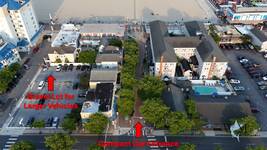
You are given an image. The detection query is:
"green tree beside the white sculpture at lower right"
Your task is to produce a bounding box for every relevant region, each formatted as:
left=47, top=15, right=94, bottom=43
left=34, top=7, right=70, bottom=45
left=231, top=116, right=260, bottom=135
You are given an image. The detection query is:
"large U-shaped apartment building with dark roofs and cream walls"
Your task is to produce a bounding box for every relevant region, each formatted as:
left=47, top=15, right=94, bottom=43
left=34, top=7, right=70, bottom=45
left=150, top=21, right=228, bottom=79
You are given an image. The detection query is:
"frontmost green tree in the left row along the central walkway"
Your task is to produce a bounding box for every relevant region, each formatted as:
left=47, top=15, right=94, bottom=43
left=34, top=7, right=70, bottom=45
left=118, top=99, right=134, bottom=117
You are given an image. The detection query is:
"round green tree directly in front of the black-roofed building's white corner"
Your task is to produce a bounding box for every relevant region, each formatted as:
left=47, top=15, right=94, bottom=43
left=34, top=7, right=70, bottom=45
left=84, top=113, right=109, bottom=134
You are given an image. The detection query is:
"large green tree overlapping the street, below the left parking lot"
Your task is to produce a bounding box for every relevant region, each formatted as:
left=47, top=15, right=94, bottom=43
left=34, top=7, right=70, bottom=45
left=45, top=133, right=76, bottom=150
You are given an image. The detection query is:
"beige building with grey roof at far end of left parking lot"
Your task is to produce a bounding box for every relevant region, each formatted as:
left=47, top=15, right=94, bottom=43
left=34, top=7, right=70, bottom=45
left=48, top=46, right=78, bottom=63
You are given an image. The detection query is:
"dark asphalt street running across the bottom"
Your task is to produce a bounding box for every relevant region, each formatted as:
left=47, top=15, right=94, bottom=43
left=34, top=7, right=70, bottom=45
left=0, top=135, right=267, bottom=150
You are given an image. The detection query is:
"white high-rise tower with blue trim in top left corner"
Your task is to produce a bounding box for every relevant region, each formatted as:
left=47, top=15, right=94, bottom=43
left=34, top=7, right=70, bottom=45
left=0, top=0, right=40, bottom=46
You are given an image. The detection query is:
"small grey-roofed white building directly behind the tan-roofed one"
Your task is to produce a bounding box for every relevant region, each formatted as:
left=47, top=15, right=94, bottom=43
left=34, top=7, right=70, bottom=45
left=95, top=53, right=122, bottom=68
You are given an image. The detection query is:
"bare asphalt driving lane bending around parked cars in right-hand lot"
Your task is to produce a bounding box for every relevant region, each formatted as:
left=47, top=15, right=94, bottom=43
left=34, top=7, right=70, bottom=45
left=224, top=50, right=267, bottom=131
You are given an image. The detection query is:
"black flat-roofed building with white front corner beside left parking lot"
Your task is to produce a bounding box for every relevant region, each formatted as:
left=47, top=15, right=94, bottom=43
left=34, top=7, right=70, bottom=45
left=80, top=83, right=116, bottom=120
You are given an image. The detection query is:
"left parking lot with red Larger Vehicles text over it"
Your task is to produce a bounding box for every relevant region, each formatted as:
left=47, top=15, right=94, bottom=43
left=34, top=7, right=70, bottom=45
left=9, top=66, right=90, bottom=127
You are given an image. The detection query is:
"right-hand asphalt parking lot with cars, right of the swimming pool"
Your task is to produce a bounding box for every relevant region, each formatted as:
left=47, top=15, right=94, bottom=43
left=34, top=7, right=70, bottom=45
left=224, top=50, right=267, bottom=131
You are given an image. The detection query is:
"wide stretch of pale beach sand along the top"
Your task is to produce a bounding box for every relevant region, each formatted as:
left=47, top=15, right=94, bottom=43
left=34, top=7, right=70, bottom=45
left=33, top=0, right=216, bottom=23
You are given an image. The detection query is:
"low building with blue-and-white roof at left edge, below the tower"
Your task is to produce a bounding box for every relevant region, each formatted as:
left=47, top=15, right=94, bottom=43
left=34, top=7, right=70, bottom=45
left=0, top=38, right=21, bottom=70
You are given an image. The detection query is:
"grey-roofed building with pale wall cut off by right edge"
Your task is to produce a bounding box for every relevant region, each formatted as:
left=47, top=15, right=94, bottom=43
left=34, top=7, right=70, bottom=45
left=249, top=28, right=267, bottom=51
